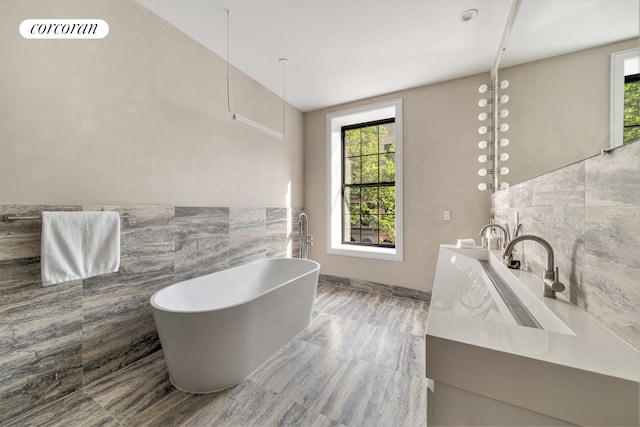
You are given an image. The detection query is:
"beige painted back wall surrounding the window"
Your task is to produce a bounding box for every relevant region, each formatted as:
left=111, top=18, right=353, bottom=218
left=304, top=74, right=490, bottom=291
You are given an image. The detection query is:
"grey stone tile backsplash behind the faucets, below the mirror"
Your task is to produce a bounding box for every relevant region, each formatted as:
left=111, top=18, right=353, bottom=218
left=492, top=143, right=640, bottom=349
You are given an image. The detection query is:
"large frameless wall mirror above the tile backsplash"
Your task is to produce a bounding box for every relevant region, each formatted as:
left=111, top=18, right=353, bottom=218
left=498, top=0, right=640, bottom=185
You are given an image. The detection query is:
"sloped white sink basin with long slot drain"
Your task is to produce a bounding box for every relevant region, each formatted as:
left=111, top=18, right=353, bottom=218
left=431, top=247, right=574, bottom=335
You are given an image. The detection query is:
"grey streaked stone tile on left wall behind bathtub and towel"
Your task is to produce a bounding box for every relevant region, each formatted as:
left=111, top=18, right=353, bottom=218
left=0, top=205, right=300, bottom=425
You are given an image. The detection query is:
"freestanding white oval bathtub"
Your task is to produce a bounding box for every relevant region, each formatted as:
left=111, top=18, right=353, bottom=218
left=151, top=258, right=320, bottom=393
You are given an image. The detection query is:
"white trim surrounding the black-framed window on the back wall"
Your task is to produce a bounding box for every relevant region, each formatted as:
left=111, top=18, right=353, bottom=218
left=327, top=98, right=403, bottom=261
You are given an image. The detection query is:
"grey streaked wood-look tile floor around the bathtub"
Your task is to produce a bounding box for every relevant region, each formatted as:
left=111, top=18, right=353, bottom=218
left=6, top=285, right=428, bottom=427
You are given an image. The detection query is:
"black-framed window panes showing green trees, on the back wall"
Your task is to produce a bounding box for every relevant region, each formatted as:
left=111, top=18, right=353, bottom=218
left=342, top=119, right=396, bottom=248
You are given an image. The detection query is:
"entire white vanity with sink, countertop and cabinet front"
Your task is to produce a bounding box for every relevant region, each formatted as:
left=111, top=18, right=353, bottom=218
left=425, top=245, right=640, bottom=426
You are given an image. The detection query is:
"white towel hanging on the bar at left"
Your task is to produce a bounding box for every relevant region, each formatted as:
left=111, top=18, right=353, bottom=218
left=40, top=212, right=120, bottom=286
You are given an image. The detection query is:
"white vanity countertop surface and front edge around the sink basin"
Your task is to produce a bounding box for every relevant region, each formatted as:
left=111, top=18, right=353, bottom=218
left=427, top=245, right=640, bottom=383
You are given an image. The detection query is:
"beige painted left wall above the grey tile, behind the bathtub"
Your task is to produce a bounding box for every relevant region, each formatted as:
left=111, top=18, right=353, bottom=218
left=0, top=0, right=303, bottom=207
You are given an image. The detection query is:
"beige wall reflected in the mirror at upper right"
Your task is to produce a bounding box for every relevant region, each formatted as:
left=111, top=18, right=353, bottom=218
left=499, top=39, right=639, bottom=185
